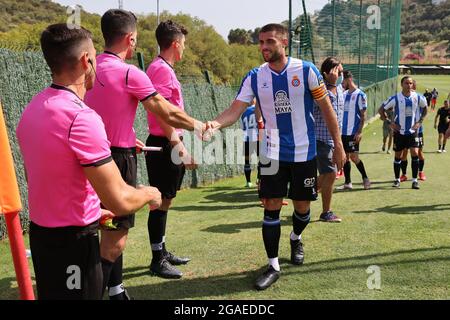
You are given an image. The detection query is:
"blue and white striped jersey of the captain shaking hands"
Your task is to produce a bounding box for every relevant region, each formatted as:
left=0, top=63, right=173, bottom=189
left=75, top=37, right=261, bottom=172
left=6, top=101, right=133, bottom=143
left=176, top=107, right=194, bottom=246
left=236, top=58, right=328, bottom=162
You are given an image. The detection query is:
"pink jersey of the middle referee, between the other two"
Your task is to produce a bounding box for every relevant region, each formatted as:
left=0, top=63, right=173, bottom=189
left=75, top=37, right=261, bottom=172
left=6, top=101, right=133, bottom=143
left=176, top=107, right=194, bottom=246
left=84, top=52, right=157, bottom=148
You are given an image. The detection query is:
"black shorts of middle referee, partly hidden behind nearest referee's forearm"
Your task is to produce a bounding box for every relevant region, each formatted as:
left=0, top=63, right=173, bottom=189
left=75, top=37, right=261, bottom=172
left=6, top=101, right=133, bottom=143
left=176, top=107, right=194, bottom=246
left=108, top=147, right=137, bottom=231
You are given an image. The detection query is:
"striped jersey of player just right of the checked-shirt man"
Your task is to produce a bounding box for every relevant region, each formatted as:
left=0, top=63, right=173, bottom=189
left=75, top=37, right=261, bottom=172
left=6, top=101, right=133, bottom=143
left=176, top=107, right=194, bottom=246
left=342, top=89, right=367, bottom=136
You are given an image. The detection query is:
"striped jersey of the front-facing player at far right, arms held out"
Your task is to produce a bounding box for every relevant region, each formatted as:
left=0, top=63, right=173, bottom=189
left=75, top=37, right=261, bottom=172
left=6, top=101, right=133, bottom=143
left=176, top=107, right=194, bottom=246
left=383, top=92, right=427, bottom=136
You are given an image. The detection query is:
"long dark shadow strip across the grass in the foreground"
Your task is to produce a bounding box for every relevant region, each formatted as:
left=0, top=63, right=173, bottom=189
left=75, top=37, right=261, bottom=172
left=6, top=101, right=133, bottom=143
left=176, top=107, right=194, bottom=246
left=124, top=246, right=450, bottom=299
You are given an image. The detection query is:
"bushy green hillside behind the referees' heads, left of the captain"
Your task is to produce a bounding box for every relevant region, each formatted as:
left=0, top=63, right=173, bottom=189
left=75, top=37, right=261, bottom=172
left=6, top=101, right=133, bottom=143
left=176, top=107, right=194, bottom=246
left=0, top=0, right=262, bottom=84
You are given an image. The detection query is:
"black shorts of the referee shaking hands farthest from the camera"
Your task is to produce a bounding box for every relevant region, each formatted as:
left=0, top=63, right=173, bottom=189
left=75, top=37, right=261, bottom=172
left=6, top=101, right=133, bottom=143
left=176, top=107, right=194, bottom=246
left=145, top=135, right=186, bottom=199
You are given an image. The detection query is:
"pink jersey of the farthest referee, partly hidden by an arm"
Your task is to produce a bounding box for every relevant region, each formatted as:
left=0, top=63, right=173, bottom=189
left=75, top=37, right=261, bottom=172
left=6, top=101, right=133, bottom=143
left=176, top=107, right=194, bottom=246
left=147, top=57, right=184, bottom=137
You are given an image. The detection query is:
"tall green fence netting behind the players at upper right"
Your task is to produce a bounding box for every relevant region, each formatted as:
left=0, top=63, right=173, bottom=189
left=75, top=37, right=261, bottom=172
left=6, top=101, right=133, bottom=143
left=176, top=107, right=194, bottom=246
left=291, top=0, right=402, bottom=87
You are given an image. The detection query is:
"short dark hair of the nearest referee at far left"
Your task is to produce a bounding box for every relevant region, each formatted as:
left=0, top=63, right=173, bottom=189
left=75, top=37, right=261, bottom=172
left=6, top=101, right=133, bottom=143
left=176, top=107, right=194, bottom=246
left=40, top=23, right=95, bottom=74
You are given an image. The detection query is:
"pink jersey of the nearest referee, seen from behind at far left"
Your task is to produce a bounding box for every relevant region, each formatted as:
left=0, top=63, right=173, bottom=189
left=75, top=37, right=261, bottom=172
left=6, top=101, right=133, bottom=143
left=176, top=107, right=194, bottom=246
left=17, top=84, right=112, bottom=228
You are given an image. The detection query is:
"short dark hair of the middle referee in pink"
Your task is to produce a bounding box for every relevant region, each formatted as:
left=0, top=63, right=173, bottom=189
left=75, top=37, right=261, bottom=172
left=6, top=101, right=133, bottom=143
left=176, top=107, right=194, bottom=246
left=101, top=9, right=137, bottom=47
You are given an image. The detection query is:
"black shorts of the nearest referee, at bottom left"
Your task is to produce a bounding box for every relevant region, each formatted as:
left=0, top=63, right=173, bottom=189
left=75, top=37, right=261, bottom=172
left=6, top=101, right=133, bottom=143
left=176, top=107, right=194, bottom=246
left=30, top=222, right=103, bottom=300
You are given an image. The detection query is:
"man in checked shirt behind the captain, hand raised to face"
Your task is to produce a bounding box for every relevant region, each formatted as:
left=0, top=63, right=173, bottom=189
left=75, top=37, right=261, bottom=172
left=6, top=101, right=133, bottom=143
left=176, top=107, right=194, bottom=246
left=314, top=57, right=344, bottom=222
